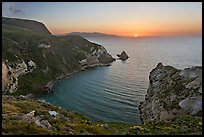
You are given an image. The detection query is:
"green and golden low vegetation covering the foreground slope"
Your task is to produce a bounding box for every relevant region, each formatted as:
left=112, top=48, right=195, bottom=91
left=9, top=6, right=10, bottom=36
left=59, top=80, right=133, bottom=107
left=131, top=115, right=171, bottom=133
left=2, top=96, right=202, bottom=135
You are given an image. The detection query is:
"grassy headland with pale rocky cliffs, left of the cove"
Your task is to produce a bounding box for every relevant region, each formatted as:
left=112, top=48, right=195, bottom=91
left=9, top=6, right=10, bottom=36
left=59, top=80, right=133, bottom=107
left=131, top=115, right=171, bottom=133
left=2, top=19, right=114, bottom=94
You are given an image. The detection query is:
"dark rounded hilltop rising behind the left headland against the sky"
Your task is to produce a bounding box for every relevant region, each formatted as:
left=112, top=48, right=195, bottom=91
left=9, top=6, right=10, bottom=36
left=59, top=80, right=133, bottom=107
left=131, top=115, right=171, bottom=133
left=2, top=17, right=51, bottom=34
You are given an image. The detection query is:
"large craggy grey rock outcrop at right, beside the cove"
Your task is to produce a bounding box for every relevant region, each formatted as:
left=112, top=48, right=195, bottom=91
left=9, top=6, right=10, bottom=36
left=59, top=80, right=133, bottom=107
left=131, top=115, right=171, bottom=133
left=139, top=63, right=202, bottom=122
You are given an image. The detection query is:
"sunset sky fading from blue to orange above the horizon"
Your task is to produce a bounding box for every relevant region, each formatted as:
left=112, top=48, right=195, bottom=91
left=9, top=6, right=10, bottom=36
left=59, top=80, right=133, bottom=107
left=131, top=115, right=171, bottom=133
left=2, top=2, right=202, bottom=36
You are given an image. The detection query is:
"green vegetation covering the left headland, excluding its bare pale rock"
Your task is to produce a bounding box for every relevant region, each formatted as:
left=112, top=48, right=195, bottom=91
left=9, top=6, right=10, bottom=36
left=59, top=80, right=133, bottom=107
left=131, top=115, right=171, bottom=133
left=2, top=22, right=110, bottom=95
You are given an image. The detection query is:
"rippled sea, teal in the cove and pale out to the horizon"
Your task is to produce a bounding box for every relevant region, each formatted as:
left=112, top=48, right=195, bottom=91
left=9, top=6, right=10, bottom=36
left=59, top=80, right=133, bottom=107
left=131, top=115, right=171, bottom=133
left=39, top=37, right=202, bottom=124
